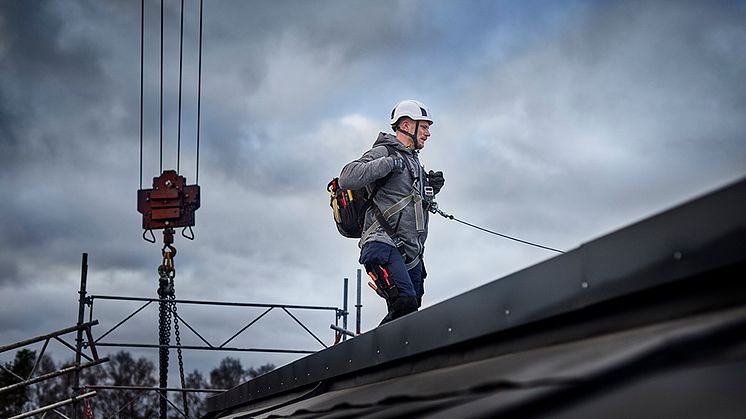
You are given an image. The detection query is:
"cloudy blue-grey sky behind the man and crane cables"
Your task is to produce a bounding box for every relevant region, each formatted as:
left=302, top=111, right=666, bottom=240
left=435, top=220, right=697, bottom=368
left=0, top=0, right=746, bottom=384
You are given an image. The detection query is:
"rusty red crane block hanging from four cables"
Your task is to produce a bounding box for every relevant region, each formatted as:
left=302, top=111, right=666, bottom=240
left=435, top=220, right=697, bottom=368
left=137, top=170, right=200, bottom=230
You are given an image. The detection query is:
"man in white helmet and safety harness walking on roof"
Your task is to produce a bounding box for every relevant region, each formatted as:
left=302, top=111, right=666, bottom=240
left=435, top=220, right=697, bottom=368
left=339, top=100, right=445, bottom=324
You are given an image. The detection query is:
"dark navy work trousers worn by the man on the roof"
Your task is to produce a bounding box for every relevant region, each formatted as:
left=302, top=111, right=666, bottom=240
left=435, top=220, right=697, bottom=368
left=360, top=242, right=427, bottom=324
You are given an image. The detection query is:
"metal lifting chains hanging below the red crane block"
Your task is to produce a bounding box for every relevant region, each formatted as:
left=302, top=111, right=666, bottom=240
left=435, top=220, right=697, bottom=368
left=158, top=242, right=189, bottom=418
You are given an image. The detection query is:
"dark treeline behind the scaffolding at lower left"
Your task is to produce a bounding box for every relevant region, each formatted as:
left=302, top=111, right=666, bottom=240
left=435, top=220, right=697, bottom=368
left=0, top=349, right=275, bottom=419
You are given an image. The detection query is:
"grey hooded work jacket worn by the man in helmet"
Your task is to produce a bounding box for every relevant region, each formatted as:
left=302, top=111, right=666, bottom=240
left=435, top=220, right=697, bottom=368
left=339, top=132, right=429, bottom=268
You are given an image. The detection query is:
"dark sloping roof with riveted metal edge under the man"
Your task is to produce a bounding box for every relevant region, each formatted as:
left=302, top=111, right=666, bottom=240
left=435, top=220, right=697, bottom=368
left=207, top=176, right=746, bottom=418
